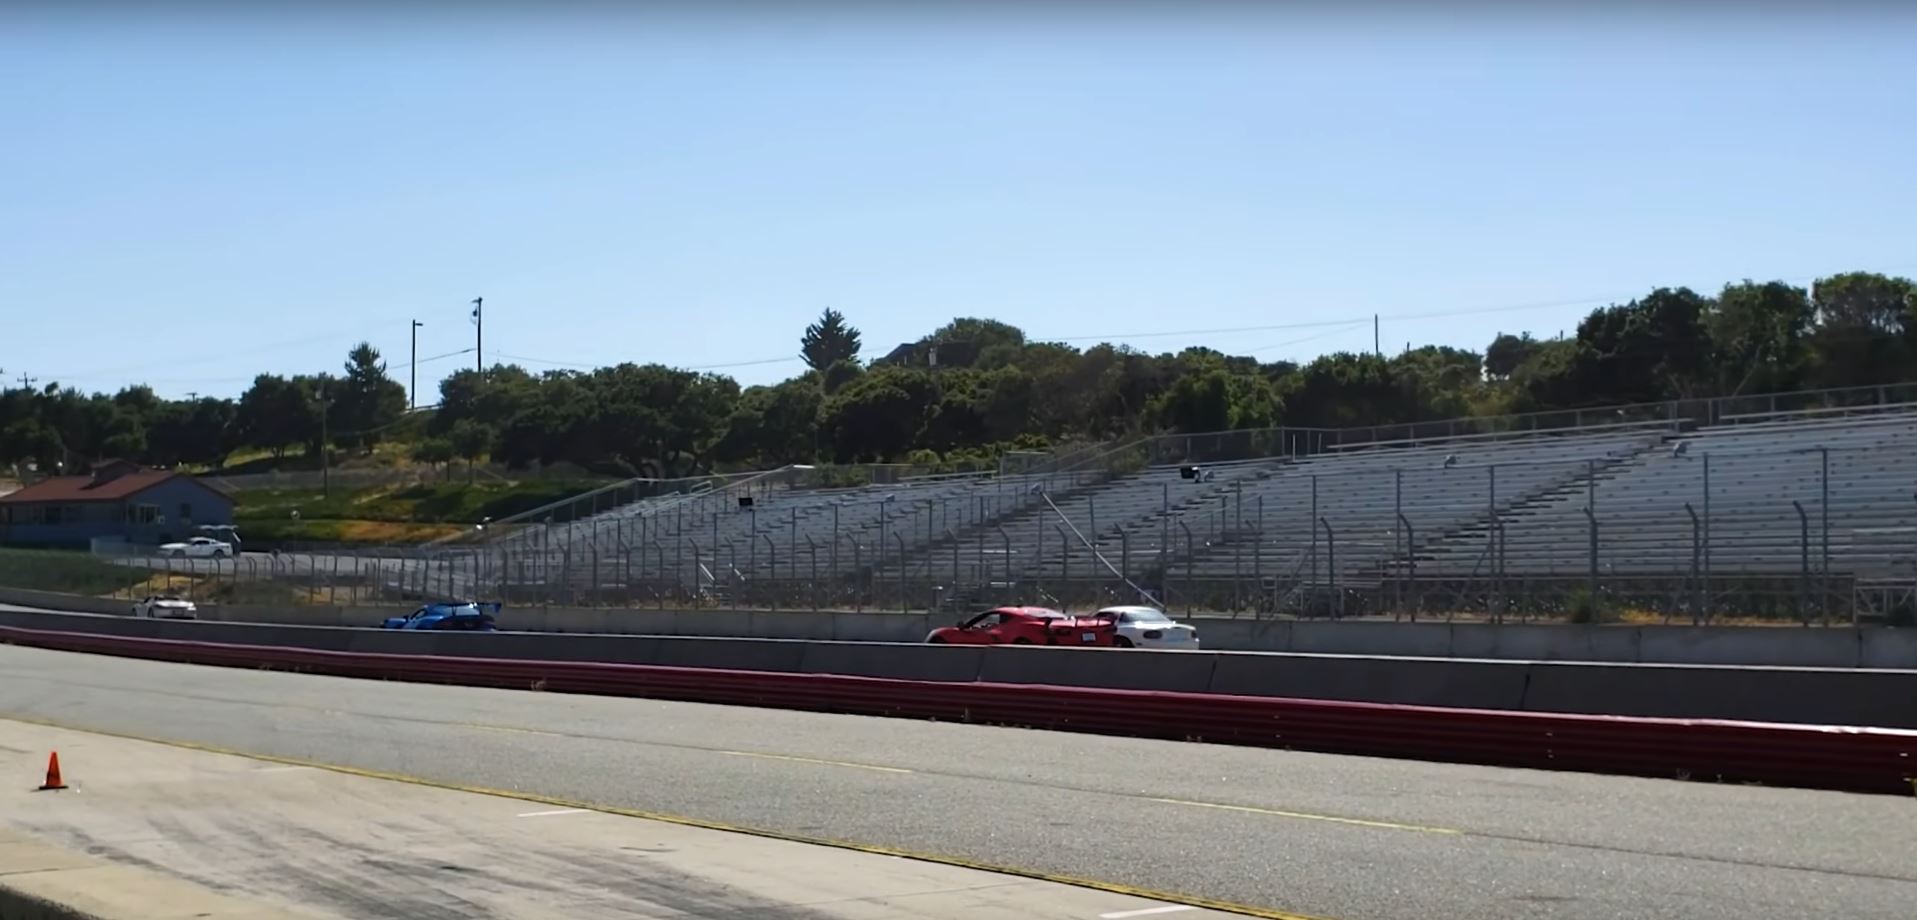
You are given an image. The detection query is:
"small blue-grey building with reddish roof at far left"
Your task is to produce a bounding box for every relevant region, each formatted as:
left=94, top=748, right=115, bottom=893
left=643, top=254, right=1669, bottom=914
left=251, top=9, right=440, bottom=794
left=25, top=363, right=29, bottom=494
left=0, top=462, right=234, bottom=546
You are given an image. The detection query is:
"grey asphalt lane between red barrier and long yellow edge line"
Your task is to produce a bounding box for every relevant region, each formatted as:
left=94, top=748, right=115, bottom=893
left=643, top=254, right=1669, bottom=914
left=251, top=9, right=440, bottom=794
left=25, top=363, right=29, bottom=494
left=0, top=646, right=1917, bottom=920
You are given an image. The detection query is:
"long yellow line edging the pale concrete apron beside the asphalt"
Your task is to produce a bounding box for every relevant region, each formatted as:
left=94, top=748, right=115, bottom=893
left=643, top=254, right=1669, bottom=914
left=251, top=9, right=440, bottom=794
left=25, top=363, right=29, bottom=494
left=0, top=713, right=1332, bottom=920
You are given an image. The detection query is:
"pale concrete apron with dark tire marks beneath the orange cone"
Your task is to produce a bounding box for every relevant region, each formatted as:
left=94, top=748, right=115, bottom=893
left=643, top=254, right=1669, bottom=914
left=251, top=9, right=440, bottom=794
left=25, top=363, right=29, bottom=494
left=0, top=721, right=1227, bottom=920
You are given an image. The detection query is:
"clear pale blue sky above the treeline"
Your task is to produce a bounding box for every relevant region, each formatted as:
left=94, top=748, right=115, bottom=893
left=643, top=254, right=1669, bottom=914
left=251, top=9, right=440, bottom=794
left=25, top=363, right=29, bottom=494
left=0, top=4, right=1917, bottom=403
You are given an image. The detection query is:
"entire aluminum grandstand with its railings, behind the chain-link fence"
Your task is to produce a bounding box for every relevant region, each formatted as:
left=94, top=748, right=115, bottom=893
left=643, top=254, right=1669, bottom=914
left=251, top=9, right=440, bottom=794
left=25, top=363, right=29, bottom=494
left=431, top=389, right=1917, bottom=619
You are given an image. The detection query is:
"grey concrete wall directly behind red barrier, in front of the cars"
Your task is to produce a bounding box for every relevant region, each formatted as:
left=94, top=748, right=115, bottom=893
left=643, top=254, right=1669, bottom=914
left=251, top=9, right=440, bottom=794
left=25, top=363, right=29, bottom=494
left=0, top=611, right=1917, bottom=728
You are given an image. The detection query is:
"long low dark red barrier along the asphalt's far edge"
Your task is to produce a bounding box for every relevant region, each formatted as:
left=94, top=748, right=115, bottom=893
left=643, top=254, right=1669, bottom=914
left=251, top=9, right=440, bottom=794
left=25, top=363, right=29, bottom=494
left=0, top=627, right=1917, bottom=794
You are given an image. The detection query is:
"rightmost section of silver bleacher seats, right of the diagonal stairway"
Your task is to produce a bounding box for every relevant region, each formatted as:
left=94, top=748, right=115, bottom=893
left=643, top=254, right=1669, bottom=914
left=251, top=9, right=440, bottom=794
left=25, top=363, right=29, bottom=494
left=1419, top=412, right=1917, bottom=579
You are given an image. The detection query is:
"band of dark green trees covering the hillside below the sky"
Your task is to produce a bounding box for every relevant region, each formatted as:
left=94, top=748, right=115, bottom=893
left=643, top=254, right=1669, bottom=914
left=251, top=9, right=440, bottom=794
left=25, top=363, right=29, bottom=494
left=0, top=272, right=1917, bottom=490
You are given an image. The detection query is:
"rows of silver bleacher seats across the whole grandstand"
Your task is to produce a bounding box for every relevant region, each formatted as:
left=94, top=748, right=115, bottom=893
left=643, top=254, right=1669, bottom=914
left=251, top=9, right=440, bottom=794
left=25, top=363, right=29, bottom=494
left=452, top=406, right=1917, bottom=604
